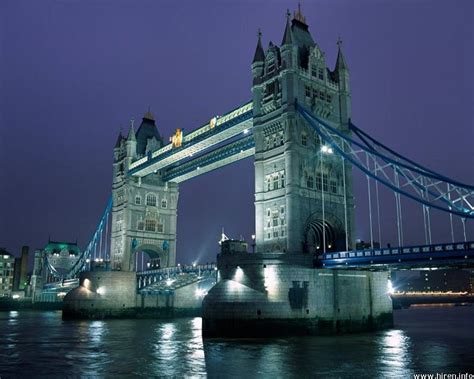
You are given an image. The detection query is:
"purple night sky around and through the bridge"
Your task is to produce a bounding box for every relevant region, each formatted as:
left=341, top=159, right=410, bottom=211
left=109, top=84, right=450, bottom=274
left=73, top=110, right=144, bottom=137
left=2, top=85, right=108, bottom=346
left=0, top=0, right=474, bottom=263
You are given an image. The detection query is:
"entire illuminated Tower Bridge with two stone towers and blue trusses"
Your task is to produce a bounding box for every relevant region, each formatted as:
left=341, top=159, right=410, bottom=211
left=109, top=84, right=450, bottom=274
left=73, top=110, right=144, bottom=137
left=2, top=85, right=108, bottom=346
left=33, top=9, right=474, bottom=335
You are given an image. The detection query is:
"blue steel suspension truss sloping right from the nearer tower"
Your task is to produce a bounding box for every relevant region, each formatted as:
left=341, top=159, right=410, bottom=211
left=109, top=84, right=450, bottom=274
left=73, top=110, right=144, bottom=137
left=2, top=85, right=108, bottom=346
left=296, top=103, right=474, bottom=220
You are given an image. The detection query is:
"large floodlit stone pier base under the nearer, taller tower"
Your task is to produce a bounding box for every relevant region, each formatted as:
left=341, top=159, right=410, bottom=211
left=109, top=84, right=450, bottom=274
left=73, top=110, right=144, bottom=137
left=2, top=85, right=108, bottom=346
left=203, top=253, right=393, bottom=337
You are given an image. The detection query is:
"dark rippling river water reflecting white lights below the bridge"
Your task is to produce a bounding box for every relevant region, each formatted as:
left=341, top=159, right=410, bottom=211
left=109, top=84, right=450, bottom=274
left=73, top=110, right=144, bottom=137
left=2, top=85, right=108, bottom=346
left=0, top=306, right=474, bottom=379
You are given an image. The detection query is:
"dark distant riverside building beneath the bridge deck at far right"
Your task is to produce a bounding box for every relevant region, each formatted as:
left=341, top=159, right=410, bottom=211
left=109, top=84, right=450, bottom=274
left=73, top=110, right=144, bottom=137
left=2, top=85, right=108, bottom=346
left=392, top=269, right=471, bottom=292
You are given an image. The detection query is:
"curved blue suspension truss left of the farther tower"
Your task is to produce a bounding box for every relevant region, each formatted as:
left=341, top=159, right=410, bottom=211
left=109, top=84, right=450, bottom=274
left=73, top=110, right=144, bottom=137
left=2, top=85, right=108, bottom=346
left=45, top=197, right=112, bottom=281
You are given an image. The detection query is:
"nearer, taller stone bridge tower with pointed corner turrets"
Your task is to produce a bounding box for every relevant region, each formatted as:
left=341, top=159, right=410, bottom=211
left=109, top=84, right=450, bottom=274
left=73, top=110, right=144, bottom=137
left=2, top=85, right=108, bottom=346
left=252, top=9, right=354, bottom=253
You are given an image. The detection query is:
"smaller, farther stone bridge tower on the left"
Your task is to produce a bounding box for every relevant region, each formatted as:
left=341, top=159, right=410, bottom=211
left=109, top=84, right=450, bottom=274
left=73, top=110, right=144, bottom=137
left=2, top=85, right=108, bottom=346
left=111, top=112, right=178, bottom=271
